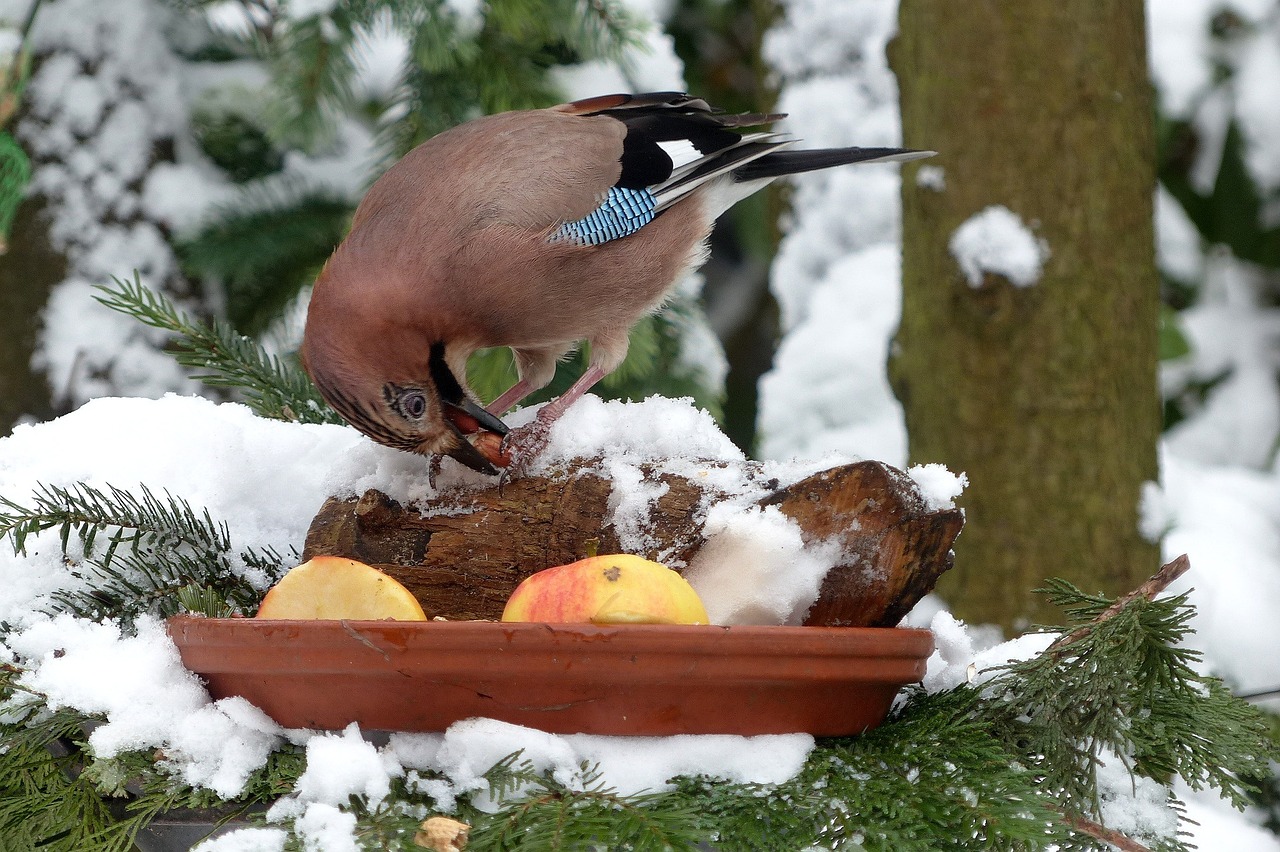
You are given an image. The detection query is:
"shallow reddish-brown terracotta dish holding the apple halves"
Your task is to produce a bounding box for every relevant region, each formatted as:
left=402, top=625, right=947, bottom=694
left=169, top=615, right=933, bottom=736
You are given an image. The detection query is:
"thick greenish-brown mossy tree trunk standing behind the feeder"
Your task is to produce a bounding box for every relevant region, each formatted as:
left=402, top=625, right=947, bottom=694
left=891, top=0, right=1160, bottom=628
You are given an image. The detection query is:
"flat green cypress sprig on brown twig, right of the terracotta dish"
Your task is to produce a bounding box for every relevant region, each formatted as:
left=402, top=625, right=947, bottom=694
left=977, top=570, right=1268, bottom=815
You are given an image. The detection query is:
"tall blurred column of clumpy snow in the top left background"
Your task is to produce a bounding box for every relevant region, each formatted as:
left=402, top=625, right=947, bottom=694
left=17, top=0, right=199, bottom=403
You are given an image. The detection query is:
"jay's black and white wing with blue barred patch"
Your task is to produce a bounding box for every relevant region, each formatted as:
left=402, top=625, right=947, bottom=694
left=550, top=92, right=792, bottom=244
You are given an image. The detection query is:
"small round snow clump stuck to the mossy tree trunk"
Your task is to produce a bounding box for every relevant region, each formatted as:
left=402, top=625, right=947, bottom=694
left=947, top=205, right=1048, bottom=288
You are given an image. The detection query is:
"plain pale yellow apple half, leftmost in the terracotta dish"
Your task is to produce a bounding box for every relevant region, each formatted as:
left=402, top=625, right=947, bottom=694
left=257, top=556, right=426, bottom=622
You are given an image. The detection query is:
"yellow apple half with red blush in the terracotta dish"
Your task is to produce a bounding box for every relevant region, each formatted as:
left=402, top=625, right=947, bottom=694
left=502, top=554, right=708, bottom=624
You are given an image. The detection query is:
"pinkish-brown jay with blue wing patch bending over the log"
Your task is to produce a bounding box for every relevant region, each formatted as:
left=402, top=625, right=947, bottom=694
left=302, top=92, right=933, bottom=473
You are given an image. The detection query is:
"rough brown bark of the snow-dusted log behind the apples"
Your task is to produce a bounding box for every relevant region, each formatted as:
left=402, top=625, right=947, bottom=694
left=303, top=462, right=964, bottom=627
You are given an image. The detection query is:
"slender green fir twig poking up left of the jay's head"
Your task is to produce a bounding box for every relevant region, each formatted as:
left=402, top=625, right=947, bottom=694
left=96, top=272, right=343, bottom=423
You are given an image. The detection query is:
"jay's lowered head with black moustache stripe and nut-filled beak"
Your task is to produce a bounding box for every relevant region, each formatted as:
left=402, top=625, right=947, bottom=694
left=302, top=342, right=507, bottom=473
